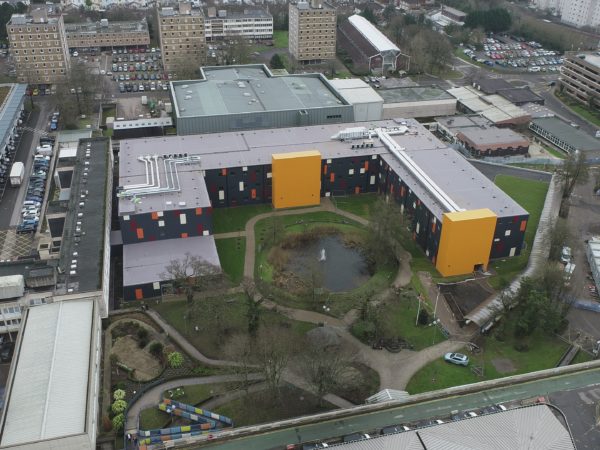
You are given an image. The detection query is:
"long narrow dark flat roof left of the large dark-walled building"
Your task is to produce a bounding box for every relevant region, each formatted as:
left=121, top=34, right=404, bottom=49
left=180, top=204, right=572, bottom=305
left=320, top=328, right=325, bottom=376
left=60, top=138, right=110, bottom=292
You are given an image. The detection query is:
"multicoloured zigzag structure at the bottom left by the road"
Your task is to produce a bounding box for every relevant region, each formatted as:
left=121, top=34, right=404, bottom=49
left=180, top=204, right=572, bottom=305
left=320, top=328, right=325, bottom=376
left=138, top=398, right=233, bottom=450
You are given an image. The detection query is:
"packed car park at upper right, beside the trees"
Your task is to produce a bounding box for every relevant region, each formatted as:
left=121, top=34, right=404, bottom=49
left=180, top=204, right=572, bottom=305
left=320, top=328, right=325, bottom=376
left=463, top=36, right=563, bottom=73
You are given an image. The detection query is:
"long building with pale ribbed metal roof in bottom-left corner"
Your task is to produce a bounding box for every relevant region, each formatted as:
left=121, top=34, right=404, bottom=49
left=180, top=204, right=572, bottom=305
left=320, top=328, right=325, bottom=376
left=0, top=297, right=101, bottom=450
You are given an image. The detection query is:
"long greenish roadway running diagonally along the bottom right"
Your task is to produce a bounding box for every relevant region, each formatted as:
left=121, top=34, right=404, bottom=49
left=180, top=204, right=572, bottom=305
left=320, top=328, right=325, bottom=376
left=202, top=369, right=600, bottom=450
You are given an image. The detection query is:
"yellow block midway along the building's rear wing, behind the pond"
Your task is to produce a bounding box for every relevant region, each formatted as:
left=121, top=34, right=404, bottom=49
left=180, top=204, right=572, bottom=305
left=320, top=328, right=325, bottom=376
left=271, top=150, right=321, bottom=208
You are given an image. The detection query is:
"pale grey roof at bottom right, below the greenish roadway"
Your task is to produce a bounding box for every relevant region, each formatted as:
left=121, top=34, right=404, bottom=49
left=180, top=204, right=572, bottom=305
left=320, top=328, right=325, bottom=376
left=330, top=405, right=576, bottom=450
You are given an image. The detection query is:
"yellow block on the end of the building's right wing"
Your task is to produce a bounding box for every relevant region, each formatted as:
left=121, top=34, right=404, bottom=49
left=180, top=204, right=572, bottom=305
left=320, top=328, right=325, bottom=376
left=435, top=208, right=497, bottom=277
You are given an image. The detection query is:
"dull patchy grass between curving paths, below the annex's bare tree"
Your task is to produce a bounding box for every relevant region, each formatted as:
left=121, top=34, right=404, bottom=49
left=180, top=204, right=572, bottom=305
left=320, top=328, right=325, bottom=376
left=152, top=295, right=315, bottom=358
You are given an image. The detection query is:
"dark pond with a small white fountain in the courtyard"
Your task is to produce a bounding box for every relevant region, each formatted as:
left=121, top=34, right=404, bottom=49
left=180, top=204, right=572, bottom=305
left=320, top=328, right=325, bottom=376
left=285, top=235, right=371, bottom=292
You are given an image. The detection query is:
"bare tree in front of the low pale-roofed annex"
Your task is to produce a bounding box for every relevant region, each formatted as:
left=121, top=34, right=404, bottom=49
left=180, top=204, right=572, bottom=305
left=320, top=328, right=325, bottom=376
left=161, top=253, right=221, bottom=304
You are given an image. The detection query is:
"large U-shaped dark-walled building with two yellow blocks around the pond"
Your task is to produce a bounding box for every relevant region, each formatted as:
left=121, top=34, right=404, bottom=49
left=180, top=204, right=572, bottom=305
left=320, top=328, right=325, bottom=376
left=119, top=120, right=529, bottom=300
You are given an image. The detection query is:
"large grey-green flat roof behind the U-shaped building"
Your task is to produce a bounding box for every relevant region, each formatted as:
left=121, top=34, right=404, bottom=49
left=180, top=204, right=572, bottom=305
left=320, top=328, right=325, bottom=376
left=172, top=67, right=345, bottom=117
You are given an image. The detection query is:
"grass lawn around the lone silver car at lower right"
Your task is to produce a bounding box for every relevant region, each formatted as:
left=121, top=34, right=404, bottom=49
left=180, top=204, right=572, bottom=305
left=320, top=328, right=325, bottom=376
left=406, top=333, right=567, bottom=394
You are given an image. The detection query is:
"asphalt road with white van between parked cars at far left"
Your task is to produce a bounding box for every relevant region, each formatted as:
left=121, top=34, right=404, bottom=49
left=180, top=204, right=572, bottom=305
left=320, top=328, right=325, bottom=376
left=0, top=97, right=50, bottom=230
